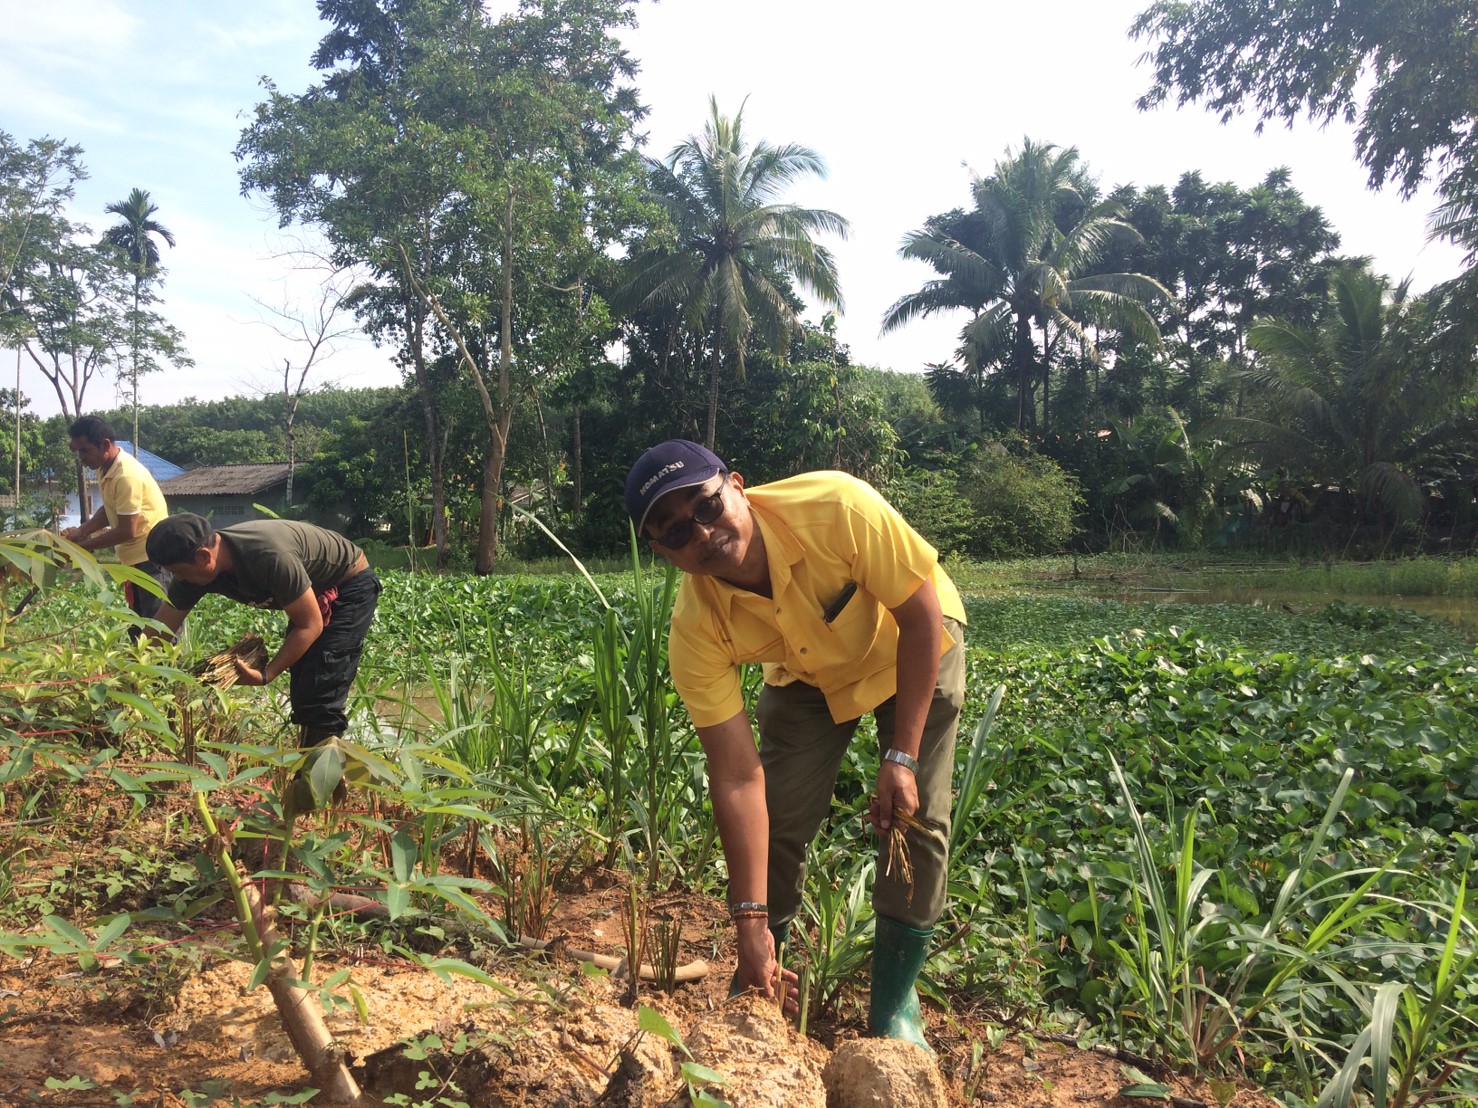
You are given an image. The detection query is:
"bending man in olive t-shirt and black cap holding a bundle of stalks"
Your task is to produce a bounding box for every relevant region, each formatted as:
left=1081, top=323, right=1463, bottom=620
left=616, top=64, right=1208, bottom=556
left=148, top=513, right=380, bottom=746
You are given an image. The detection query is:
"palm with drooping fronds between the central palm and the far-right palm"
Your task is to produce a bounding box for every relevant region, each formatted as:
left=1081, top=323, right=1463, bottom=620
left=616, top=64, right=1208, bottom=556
left=882, top=139, right=1169, bottom=430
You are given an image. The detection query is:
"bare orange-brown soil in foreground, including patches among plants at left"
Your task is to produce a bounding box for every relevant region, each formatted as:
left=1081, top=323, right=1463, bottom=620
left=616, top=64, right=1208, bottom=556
left=0, top=796, right=1276, bottom=1108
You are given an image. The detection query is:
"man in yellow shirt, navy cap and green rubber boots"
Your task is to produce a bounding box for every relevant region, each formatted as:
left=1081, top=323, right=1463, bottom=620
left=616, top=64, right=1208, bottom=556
left=625, top=439, right=965, bottom=1047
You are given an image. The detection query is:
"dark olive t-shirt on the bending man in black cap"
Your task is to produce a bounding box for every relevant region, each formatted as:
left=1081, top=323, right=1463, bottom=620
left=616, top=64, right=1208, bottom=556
left=170, top=520, right=359, bottom=612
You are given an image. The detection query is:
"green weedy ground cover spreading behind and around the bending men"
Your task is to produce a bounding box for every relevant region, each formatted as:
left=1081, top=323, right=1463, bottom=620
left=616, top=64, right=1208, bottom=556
left=0, top=540, right=1478, bottom=1105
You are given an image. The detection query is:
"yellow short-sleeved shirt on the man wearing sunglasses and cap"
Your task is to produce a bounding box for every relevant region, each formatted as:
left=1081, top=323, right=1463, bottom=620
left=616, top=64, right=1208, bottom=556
left=668, top=471, right=965, bottom=727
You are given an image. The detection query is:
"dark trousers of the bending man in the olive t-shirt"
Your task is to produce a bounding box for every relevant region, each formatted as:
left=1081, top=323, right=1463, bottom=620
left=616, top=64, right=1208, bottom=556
left=288, top=569, right=380, bottom=742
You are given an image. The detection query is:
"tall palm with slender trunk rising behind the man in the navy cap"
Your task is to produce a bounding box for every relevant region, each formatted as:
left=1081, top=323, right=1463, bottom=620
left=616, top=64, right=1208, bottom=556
left=618, top=98, right=847, bottom=448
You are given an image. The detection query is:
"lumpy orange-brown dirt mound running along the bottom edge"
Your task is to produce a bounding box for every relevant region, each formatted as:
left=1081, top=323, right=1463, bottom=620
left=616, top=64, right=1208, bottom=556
left=0, top=956, right=1276, bottom=1108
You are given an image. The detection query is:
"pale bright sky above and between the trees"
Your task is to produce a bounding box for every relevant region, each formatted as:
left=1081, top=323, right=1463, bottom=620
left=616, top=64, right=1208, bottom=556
left=0, top=0, right=1460, bottom=415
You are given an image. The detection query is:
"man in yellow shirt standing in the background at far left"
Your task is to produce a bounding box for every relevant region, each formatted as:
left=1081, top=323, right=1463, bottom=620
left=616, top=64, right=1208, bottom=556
left=62, top=415, right=168, bottom=638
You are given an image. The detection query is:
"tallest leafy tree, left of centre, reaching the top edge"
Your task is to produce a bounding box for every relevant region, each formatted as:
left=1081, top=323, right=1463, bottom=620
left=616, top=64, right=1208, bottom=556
left=236, top=0, right=641, bottom=569
